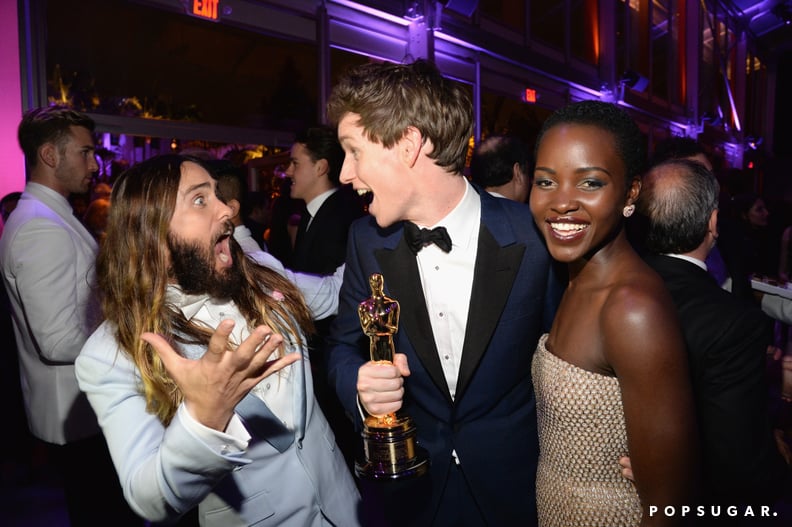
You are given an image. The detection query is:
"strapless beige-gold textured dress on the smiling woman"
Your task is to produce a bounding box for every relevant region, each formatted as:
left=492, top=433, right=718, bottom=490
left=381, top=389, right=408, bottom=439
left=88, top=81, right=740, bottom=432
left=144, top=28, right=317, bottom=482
left=531, top=335, right=641, bottom=527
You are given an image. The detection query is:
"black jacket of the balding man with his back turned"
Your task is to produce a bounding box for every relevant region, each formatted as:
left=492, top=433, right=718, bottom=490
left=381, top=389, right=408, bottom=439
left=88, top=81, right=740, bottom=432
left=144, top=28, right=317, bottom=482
left=645, top=255, right=786, bottom=504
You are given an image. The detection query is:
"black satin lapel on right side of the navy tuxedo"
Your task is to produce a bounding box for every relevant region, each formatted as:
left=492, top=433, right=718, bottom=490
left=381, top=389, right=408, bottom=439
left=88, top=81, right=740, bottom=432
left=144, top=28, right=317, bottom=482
left=456, top=224, right=525, bottom=401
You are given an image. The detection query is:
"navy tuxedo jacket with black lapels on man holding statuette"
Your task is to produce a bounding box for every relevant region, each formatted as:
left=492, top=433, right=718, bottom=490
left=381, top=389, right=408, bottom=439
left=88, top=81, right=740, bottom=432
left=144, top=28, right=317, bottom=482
left=328, top=189, right=562, bottom=525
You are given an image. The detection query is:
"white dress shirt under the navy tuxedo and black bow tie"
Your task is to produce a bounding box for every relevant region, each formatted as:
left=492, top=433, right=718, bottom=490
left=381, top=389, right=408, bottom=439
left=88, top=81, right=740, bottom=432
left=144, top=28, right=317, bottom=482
left=416, top=183, right=481, bottom=399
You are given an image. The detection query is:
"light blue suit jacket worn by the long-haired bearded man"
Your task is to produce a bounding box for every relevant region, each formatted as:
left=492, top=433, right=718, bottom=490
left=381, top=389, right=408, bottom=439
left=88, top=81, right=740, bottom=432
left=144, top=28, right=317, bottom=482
left=76, top=322, right=360, bottom=527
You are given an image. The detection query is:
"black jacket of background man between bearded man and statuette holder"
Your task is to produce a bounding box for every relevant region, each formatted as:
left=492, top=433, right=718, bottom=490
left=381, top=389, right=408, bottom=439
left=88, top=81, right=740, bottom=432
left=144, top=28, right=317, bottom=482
left=291, top=187, right=364, bottom=275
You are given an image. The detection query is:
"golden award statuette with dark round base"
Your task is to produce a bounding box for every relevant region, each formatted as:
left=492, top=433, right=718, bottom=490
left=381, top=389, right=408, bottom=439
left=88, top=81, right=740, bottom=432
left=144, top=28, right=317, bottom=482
left=355, top=273, right=429, bottom=480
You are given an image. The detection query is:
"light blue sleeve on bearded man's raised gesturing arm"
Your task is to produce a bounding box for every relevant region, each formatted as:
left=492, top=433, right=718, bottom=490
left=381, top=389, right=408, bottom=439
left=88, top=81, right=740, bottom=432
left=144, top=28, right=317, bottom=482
left=76, top=324, right=250, bottom=522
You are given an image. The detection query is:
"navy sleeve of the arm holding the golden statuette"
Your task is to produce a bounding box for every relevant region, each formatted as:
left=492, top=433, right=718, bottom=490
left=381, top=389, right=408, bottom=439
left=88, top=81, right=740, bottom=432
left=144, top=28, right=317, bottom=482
left=327, top=223, right=378, bottom=427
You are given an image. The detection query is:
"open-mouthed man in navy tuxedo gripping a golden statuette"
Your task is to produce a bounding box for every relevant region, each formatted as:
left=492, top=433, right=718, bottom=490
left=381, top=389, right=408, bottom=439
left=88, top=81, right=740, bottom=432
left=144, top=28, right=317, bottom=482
left=328, top=60, right=563, bottom=527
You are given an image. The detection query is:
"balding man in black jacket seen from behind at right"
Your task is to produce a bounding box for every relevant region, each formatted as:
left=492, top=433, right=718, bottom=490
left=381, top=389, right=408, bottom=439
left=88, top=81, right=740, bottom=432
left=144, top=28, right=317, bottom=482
left=638, top=159, right=787, bottom=525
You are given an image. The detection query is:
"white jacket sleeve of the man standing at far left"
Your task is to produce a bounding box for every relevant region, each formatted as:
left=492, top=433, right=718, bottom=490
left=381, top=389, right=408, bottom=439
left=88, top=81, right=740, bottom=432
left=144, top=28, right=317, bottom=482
left=4, top=218, right=95, bottom=364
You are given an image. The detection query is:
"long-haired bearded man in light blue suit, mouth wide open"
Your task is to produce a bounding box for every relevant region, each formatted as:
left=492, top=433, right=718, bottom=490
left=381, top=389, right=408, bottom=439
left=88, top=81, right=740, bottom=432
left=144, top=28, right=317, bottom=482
left=77, top=155, right=361, bottom=526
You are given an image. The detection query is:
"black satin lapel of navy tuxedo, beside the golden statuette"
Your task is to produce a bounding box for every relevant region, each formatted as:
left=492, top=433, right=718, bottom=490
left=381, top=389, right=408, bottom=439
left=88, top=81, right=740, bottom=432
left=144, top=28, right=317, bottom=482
left=372, top=238, right=451, bottom=402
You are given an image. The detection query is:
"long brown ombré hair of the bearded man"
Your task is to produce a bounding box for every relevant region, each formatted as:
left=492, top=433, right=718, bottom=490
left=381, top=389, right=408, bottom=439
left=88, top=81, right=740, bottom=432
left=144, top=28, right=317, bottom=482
left=97, top=154, right=313, bottom=424
